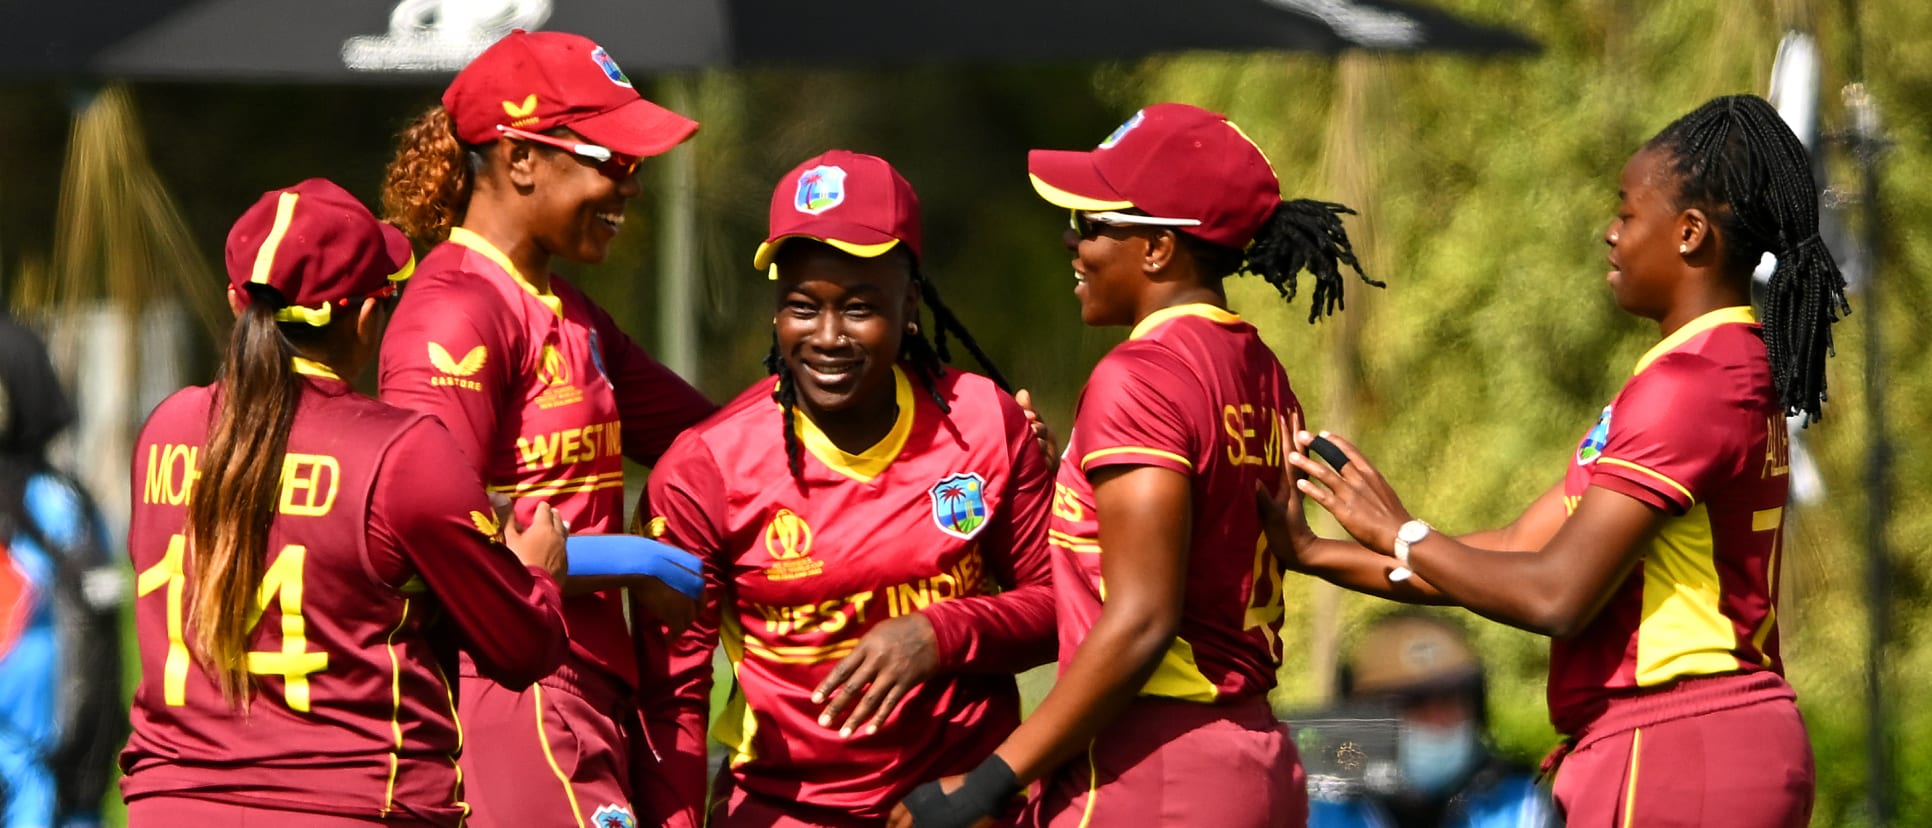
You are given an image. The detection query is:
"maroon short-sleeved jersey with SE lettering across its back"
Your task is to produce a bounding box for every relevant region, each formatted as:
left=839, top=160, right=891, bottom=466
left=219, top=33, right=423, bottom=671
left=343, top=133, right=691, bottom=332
left=1049, top=305, right=1300, bottom=703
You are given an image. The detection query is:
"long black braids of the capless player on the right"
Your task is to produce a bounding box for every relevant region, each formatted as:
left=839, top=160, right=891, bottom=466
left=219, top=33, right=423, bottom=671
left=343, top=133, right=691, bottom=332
left=1644, top=95, right=1851, bottom=425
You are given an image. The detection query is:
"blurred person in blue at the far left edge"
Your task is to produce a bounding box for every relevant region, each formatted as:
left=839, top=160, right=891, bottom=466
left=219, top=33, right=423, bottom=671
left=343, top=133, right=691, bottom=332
left=0, top=315, right=128, bottom=828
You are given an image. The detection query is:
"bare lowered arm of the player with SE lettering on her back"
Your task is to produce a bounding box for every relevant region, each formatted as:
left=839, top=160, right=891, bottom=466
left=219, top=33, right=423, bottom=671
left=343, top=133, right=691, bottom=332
left=887, top=465, right=1194, bottom=828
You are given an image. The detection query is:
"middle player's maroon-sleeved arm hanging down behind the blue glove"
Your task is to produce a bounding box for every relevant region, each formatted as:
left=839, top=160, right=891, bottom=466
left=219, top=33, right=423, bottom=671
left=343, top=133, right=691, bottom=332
left=632, top=438, right=730, bottom=828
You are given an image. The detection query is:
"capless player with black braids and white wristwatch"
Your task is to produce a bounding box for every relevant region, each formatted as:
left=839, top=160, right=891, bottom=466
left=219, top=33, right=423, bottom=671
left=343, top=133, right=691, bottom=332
left=1283, top=95, right=1849, bottom=826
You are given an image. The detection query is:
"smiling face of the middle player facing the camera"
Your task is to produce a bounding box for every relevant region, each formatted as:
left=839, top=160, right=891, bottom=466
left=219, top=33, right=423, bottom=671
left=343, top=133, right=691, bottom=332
left=773, top=239, right=918, bottom=428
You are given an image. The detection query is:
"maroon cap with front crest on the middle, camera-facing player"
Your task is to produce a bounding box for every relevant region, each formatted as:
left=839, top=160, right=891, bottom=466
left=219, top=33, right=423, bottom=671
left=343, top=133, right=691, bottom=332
left=752, top=149, right=920, bottom=270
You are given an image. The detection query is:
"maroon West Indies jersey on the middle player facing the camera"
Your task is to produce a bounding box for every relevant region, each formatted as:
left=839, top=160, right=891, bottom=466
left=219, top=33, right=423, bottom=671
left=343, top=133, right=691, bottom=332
left=647, top=369, right=1051, bottom=818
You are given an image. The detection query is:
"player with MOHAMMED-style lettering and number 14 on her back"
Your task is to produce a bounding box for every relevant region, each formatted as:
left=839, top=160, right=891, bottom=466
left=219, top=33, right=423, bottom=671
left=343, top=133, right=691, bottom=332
left=122, top=179, right=566, bottom=826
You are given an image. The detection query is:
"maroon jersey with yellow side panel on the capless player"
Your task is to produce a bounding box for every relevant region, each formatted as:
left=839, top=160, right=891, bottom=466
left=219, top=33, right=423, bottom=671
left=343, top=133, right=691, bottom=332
left=1549, top=307, right=1791, bottom=733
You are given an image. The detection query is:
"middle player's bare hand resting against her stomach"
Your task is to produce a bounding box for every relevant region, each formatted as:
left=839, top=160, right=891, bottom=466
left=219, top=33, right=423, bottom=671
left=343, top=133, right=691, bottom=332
left=811, top=612, right=939, bottom=737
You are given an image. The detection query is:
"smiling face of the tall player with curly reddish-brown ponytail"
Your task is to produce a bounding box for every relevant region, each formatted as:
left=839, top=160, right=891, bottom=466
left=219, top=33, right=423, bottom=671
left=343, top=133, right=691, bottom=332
left=527, top=131, right=639, bottom=264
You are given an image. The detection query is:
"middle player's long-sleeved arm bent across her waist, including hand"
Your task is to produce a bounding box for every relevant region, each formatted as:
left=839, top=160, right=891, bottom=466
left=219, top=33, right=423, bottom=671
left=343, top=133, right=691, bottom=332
left=811, top=394, right=1055, bottom=733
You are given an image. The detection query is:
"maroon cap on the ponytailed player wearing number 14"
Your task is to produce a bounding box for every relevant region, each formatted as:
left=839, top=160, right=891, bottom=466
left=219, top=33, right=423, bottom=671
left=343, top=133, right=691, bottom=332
left=226, top=178, right=415, bottom=326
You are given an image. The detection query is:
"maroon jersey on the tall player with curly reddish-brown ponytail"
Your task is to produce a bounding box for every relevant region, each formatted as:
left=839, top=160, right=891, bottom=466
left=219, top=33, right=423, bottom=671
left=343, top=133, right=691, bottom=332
left=381, top=228, right=715, bottom=685
